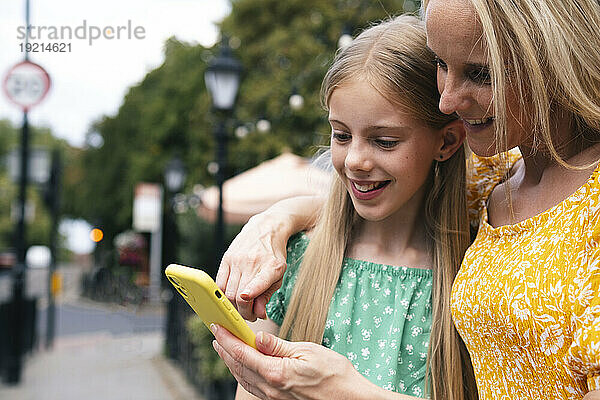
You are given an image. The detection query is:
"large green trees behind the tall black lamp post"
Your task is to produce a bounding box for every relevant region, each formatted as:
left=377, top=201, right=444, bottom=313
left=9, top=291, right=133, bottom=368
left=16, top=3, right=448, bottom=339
left=74, top=0, right=412, bottom=252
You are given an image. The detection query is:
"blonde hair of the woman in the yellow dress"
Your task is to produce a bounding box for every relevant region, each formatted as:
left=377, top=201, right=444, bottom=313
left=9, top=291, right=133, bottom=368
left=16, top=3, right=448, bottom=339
left=423, top=0, right=600, bottom=169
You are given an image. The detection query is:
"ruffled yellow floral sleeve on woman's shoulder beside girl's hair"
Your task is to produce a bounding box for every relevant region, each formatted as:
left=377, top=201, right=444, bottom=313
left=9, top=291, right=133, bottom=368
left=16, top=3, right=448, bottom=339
left=467, top=148, right=522, bottom=227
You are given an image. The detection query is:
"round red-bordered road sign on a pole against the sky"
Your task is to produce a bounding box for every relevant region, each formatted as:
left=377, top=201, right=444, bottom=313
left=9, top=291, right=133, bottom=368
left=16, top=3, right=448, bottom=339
left=3, top=61, right=50, bottom=111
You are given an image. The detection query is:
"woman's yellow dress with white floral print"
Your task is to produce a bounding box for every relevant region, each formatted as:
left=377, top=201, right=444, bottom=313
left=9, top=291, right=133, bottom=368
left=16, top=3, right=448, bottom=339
left=451, top=149, right=600, bottom=400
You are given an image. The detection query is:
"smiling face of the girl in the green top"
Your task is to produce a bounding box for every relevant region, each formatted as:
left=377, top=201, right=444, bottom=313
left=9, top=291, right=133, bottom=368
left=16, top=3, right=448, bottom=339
left=329, top=79, right=444, bottom=221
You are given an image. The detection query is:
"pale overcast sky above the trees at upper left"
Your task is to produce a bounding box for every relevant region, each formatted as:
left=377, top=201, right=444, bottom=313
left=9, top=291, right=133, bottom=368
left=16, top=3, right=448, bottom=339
left=0, top=0, right=230, bottom=146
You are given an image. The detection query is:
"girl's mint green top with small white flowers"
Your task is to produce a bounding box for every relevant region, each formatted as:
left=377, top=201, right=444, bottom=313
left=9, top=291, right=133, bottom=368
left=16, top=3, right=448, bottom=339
left=267, top=233, right=432, bottom=397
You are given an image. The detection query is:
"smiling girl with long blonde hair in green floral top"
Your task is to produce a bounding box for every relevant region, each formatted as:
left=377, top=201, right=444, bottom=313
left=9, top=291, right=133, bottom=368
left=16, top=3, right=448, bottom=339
left=227, top=16, right=476, bottom=400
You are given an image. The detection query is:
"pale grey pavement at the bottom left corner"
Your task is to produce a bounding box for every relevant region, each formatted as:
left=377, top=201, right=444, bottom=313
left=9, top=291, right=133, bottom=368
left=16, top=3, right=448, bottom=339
left=0, top=333, right=201, bottom=400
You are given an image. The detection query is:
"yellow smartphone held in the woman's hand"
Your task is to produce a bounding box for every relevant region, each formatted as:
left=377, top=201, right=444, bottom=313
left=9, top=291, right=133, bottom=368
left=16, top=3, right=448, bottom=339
left=165, top=264, right=256, bottom=348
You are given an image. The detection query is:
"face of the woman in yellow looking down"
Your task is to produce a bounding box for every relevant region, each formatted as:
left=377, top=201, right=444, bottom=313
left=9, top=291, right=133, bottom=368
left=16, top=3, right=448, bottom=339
left=425, top=0, right=529, bottom=156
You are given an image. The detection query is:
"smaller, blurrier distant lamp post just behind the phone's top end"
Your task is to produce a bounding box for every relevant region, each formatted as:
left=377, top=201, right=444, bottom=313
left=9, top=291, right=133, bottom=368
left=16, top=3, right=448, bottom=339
left=163, top=157, right=186, bottom=359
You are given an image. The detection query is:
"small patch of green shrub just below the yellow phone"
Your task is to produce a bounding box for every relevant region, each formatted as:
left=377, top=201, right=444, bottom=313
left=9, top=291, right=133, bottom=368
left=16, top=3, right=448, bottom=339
left=186, top=315, right=233, bottom=382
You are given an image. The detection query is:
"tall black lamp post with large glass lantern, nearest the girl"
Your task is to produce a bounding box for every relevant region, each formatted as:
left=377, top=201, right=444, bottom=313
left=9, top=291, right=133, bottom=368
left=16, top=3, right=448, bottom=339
left=204, top=37, right=242, bottom=268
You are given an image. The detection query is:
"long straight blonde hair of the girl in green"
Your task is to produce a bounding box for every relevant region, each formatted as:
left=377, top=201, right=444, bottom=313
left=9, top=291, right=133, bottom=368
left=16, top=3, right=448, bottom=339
left=280, top=15, right=477, bottom=400
